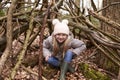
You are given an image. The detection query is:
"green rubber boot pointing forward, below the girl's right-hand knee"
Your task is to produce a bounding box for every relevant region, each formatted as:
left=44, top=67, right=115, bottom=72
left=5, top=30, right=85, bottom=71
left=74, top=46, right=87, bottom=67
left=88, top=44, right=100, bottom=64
left=60, top=61, right=69, bottom=80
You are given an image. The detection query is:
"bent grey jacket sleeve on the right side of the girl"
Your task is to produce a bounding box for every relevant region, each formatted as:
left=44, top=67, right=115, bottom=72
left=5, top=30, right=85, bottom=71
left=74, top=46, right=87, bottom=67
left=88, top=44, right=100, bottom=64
left=71, top=39, right=86, bottom=55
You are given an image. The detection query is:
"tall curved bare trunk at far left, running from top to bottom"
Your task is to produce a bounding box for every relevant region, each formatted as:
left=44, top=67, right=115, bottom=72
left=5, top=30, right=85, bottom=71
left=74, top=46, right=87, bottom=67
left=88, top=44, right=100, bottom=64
left=0, top=0, right=17, bottom=75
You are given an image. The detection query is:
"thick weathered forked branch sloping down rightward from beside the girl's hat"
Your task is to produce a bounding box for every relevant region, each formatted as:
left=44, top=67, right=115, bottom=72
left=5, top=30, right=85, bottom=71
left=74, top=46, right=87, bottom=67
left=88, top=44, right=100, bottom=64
left=69, top=22, right=120, bottom=66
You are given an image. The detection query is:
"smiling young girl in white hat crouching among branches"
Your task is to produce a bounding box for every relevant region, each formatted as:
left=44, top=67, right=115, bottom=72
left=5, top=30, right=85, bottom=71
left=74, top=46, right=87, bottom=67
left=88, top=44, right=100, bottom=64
left=43, top=19, right=86, bottom=80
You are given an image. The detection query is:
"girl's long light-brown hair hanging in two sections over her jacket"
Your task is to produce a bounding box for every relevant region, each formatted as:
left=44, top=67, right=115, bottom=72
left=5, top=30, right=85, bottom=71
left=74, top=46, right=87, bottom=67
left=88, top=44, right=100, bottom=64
left=52, top=36, right=71, bottom=57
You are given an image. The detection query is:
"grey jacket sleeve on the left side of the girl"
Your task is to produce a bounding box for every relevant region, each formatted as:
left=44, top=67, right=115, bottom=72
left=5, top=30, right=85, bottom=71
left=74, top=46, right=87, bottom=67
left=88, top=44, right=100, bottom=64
left=43, top=36, right=52, bottom=57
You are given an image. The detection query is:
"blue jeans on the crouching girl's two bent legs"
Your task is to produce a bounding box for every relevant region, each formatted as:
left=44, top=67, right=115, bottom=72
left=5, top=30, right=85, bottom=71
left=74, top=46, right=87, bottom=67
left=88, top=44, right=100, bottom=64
left=47, top=50, right=73, bottom=67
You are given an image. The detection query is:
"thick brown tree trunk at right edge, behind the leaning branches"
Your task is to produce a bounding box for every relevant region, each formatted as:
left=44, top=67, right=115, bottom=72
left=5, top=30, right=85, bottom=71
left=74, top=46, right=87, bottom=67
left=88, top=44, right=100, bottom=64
left=96, top=0, right=120, bottom=78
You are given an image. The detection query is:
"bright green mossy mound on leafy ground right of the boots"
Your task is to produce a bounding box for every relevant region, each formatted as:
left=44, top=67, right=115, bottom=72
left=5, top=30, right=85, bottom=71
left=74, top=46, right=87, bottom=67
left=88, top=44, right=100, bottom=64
left=80, top=63, right=111, bottom=80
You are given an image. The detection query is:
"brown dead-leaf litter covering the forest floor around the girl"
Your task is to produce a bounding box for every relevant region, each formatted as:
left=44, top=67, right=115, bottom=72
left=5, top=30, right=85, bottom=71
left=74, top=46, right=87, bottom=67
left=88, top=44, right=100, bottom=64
left=2, top=38, right=116, bottom=80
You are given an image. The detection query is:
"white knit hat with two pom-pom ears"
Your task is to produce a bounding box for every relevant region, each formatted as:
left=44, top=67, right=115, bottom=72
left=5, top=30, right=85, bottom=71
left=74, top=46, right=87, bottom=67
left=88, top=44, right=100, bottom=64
left=52, top=19, right=69, bottom=35
